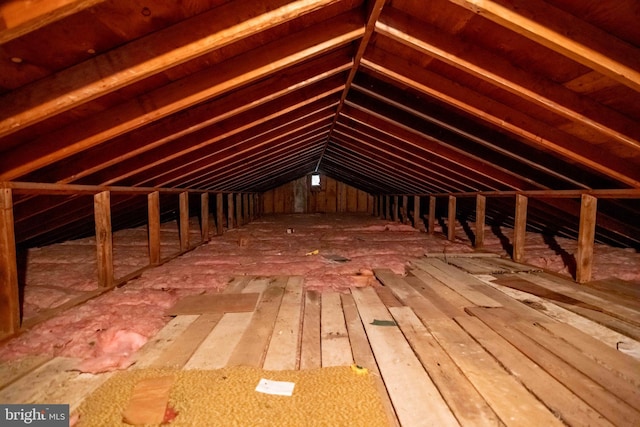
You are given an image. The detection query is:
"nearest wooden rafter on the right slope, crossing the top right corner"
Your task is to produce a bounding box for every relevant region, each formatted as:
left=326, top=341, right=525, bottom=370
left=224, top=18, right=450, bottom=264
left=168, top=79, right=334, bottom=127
left=449, top=0, right=640, bottom=92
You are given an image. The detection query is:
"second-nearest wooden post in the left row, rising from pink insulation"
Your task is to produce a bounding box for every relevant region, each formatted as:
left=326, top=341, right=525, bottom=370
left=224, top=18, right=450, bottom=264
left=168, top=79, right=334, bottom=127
left=93, top=191, right=113, bottom=288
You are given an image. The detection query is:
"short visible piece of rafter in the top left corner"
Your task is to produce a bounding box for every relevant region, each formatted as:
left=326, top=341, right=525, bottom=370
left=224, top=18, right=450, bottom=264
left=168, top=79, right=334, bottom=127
left=0, top=0, right=105, bottom=45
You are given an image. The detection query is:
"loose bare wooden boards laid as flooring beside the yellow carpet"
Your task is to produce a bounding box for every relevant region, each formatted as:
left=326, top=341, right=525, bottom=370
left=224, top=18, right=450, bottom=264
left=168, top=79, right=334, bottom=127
left=0, top=257, right=640, bottom=426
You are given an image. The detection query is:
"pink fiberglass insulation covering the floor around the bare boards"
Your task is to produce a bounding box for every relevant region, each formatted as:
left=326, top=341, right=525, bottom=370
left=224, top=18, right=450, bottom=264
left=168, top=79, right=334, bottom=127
left=0, top=214, right=640, bottom=372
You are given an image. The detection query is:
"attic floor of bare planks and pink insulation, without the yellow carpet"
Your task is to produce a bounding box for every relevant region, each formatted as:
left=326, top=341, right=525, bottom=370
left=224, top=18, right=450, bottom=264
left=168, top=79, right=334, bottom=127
left=0, top=215, right=640, bottom=426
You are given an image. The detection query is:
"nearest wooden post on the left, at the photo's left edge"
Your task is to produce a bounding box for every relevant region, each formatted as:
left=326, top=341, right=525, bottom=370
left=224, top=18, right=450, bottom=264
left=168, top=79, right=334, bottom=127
left=0, top=188, right=20, bottom=334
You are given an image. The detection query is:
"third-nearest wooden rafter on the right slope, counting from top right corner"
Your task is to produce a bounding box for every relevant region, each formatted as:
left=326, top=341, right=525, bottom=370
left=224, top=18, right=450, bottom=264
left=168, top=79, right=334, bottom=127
left=362, top=53, right=640, bottom=188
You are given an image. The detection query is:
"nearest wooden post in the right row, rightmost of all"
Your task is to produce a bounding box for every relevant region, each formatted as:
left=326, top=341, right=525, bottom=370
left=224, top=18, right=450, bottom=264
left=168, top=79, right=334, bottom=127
left=576, top=194, right=598, bottom=283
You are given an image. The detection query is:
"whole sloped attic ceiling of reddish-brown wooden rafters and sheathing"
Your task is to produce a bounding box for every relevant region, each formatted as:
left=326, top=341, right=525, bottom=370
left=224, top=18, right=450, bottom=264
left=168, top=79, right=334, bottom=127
left=0, top=0, right=640, bottom=248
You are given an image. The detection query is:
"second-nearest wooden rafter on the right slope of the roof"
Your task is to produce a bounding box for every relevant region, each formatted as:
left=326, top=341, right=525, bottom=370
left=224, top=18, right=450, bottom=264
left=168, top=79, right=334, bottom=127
left=376, top=8, right=640, bottom=150
